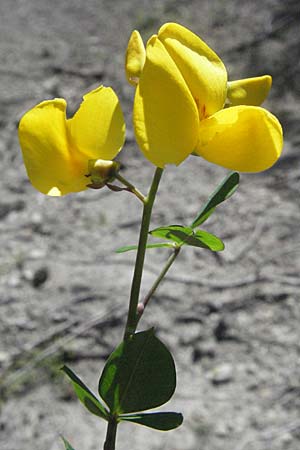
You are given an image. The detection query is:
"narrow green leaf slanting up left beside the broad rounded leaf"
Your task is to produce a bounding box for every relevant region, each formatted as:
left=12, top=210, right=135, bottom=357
left=61, top=366, right=108, bottom=420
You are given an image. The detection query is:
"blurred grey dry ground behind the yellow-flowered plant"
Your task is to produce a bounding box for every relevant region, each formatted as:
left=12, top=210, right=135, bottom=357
left=0, top=0, right=300, bottom=450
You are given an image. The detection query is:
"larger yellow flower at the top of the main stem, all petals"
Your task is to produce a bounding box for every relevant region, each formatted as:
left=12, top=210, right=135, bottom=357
left=126, top=23, right=283, bottom=172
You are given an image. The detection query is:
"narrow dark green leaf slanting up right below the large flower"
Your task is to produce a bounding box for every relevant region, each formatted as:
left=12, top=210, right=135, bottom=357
left=191, top=172, right=240, bottom=228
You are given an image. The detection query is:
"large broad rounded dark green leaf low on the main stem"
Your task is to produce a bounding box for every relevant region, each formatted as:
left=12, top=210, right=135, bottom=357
left=99, top=329, right=176, bottom=414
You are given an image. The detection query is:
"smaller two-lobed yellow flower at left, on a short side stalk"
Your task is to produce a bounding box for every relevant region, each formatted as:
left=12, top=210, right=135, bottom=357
left=19, top=86, right=125, bottom=196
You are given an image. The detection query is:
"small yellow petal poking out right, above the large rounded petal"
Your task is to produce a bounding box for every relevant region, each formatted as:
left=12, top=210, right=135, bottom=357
left=227, top=75, right=272, bottom=106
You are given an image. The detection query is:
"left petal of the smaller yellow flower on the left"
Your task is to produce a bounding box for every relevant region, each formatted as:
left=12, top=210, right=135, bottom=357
left=19, top=99, right=87, bottom=196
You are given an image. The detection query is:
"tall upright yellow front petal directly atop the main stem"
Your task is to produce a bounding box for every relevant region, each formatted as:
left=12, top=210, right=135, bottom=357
left=133, top=36, right=199, bottom=167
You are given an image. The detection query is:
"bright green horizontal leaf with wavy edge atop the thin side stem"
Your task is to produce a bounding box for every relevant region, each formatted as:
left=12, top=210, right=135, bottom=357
left=150, top=225, right=224, bottom=252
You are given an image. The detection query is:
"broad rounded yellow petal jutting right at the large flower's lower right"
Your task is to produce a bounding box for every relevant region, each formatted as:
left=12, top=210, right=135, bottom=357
left=195, top=106, right=283, bottom=172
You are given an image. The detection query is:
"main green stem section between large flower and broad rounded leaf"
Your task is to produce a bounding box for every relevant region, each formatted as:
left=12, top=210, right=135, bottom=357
left=124, top=167, right=163, bottom=339
